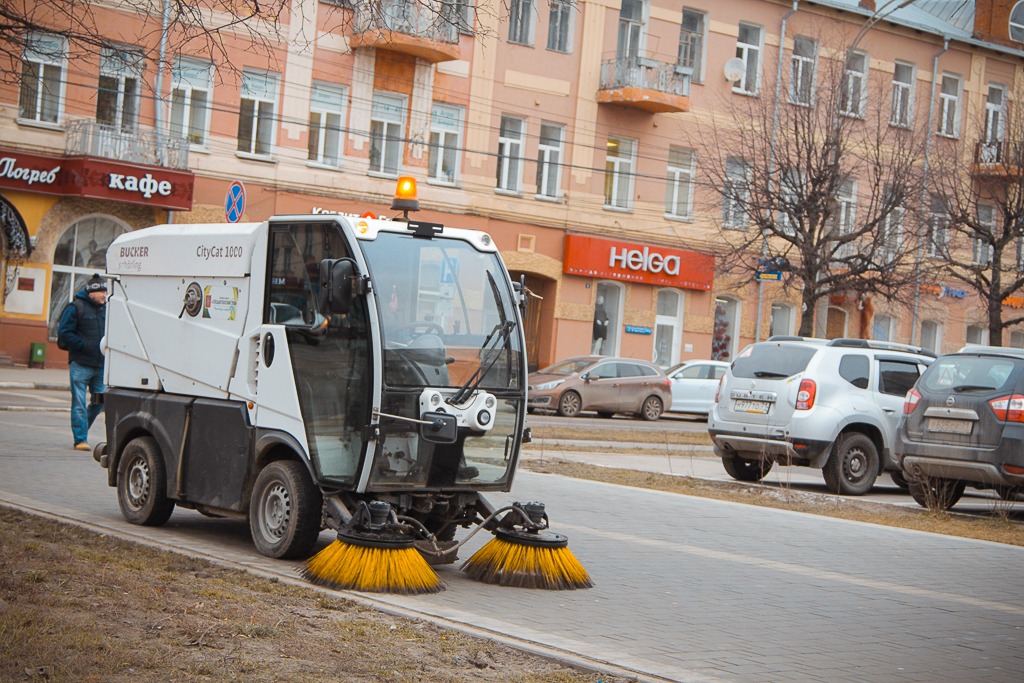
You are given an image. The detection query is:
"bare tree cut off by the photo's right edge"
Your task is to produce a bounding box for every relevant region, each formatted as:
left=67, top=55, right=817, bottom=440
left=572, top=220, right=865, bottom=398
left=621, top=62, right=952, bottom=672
left=928, top=93, right=1024, bottom=346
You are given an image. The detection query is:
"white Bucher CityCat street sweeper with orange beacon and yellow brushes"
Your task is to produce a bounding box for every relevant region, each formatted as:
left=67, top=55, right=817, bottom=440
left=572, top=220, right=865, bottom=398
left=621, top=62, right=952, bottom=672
left=94, top=178, right=591, bottom=593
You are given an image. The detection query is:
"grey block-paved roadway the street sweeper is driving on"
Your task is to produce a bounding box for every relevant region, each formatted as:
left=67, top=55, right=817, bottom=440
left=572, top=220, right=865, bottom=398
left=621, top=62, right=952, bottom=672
left=0, top=389, right=1024, bottom=682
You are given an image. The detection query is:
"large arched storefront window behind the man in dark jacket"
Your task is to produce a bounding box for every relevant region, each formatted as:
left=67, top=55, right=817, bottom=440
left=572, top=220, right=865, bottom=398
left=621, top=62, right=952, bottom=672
left=48, top=216, right=127, bottom=340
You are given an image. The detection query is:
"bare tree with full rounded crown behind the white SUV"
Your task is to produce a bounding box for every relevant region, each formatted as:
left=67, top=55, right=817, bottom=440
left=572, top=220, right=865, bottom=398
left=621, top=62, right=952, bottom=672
left=695, top=28, right=922, bottom=336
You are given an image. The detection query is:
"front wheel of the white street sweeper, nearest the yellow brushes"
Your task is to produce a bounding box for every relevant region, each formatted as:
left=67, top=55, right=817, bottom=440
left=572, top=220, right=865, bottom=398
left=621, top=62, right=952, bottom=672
left=249, top=460, right=324, bottom=559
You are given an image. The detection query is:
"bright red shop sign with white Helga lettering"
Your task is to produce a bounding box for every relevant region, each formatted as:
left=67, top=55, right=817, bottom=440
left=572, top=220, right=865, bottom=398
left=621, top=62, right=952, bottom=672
left=562, top=234, right=715, bottom=290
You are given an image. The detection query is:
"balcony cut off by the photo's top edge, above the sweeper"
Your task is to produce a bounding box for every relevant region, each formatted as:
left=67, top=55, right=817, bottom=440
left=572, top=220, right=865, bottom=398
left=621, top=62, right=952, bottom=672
left=351, top=0, right=459, bottom=63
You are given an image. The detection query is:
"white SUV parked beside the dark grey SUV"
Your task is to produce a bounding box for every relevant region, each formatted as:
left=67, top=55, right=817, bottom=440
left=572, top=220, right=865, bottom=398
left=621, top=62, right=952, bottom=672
left=708, top=337, right=935, bottom=496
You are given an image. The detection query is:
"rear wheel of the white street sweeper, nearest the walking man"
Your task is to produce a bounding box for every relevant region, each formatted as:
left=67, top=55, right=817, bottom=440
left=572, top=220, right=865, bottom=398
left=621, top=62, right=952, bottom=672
left=118, top=436, right=174, bottom=526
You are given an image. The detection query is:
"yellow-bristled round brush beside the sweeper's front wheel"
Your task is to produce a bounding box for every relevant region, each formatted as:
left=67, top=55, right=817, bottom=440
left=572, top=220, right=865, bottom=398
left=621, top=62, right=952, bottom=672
left=299, top=501, right=444, bottom=595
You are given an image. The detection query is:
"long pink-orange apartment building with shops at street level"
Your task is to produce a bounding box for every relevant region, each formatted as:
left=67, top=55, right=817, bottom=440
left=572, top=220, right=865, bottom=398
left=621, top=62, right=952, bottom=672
left=0, top=0, right=1024, bottom=367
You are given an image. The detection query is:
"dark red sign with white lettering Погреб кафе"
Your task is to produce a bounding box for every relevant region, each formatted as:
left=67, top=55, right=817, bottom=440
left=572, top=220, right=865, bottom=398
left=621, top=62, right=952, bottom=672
left=0, top=144, right=195, bottom=210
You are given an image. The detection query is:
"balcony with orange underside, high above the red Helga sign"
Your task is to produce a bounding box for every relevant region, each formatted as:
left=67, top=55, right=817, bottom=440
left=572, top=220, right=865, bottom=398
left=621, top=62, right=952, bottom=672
left=597, top=57, right=690, bottom=114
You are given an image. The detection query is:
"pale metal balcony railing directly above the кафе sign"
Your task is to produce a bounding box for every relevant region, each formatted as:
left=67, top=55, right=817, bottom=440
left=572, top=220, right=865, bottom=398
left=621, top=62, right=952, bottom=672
left=65, top=119, right=188, bottom=169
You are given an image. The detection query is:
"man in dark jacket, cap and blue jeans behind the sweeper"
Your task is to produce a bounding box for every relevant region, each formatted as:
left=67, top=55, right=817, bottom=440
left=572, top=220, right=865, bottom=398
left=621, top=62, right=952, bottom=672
left=57, top=273, right=106, bottom=451
